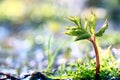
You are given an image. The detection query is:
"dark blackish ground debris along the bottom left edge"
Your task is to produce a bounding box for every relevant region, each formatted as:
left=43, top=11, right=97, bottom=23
left=0, top=72, right=59, bottom=80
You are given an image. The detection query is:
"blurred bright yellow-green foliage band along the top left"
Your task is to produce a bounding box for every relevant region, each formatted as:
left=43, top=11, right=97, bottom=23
left=0, top=0, right=66, bottom=23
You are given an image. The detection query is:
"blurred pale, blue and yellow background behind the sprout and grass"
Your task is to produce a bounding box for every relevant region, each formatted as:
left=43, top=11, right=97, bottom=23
left=0, top=0, right=120, bottom=73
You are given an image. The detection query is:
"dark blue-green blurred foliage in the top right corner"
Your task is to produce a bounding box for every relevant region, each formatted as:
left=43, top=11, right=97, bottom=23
left=86, top=0, right=120, bottom=29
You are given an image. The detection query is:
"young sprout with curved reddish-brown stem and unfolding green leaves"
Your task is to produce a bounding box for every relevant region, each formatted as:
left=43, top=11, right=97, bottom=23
left=64, top=12, right=108, bottom=77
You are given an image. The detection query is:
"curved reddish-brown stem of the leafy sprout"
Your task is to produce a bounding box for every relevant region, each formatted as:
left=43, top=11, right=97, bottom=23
left=89, top=37, right=100, bottom=77
